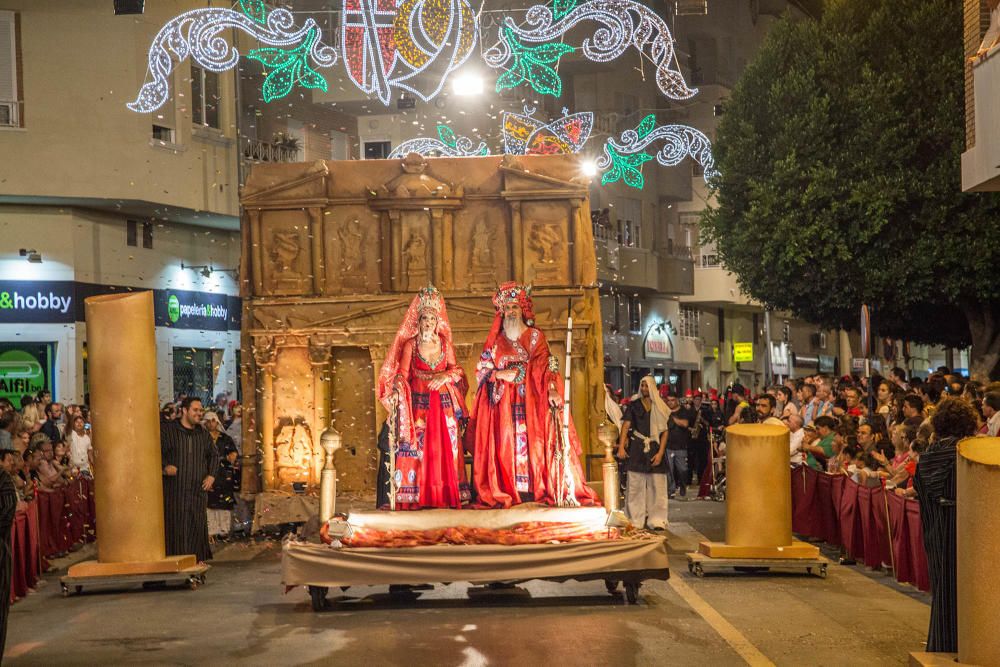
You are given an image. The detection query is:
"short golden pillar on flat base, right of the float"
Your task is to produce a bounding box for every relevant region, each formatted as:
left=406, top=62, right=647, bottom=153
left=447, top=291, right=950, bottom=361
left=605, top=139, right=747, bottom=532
left=700, top=424, right=819, bottom=558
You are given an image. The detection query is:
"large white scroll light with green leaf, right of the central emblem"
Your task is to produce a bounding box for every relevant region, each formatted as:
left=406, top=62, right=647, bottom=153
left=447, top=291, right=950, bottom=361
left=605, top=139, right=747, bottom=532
left=483, top=0, right=698, bottom=100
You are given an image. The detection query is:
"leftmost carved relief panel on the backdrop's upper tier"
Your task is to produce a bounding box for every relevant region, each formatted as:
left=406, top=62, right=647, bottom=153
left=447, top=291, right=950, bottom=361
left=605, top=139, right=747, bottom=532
left=255, top=210, right=313, bottom=295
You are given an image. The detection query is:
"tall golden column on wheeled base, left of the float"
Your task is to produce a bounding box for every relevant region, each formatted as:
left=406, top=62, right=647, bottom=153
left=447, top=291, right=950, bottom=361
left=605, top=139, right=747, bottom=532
left=69, top=291, right=196, bottom=577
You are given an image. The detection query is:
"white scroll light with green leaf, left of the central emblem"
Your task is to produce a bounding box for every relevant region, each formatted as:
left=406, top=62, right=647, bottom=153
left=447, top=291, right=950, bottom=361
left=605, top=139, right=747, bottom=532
left=126, top=6, right=337, bottom=113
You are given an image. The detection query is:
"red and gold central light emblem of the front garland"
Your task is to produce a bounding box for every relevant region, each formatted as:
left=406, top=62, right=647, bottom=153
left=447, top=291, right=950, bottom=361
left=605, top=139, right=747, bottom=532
left=341, top=0, right=478, bottom=106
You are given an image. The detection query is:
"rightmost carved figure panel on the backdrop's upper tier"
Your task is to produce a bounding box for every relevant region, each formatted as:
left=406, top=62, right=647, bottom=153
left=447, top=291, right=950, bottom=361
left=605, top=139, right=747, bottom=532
left=522, top=202, right=572, bottom=285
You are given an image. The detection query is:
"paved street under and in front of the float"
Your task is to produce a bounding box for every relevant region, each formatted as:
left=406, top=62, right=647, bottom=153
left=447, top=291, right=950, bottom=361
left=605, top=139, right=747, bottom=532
left=7, top=502, right=929, bottom=665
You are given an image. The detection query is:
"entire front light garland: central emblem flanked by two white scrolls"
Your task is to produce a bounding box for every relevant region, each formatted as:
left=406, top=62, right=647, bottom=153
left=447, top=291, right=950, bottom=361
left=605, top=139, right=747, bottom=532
left=128, top=0, right=698, bottom=113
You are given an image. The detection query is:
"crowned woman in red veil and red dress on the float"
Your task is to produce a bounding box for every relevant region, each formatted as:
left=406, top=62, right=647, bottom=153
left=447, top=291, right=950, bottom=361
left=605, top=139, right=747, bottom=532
left=376, top=286, right=471, bottom=509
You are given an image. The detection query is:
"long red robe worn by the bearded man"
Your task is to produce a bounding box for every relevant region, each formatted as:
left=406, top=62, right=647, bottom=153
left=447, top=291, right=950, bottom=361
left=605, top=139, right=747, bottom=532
left=465, top=327, right=599, bottom=508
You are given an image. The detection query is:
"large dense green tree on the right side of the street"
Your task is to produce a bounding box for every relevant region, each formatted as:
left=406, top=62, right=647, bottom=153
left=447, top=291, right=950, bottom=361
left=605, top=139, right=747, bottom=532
left=702, top=0, right=1000, bottom=378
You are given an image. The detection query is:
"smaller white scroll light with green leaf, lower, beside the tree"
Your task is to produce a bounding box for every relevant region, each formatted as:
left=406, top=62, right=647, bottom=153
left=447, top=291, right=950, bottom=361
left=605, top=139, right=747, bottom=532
left=597, top=114, right=719, bottom=189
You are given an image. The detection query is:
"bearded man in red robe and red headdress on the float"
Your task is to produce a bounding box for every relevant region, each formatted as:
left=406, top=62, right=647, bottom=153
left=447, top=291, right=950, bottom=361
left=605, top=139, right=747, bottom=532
left=465, top=282, right=599, bottom=508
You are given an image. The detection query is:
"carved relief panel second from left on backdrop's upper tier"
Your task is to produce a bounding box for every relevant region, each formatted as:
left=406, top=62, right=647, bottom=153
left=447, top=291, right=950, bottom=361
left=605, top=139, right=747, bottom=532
left=323, top=206, right=380, bottom=294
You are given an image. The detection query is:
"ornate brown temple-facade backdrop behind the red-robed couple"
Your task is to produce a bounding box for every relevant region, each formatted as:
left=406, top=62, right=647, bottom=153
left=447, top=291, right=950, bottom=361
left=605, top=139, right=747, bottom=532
left=240, top=154, right=604, bottom=492
